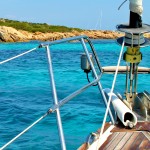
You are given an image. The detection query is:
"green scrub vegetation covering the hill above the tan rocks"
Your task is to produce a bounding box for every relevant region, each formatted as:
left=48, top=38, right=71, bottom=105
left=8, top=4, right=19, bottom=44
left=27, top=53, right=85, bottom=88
left=0, top=19, right=82, bottom=33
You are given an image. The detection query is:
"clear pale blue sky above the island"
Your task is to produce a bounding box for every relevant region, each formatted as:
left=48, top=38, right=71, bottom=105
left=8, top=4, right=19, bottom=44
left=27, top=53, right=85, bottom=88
left=0, top=0, right=150, bottom=30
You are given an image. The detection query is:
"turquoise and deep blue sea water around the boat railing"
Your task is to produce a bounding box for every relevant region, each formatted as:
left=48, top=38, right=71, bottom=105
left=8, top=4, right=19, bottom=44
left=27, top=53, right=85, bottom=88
left=0, top=40, right=150, bottom=150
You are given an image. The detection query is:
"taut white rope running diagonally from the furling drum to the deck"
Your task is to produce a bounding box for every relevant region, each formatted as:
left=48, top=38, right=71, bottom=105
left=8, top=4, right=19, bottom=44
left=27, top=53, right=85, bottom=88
left=96, top=40, right=125, bottom=150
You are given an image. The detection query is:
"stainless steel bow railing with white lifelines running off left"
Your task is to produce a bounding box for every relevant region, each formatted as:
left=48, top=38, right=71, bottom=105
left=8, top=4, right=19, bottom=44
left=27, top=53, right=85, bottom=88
left=0, top=36, right=115, bottom=150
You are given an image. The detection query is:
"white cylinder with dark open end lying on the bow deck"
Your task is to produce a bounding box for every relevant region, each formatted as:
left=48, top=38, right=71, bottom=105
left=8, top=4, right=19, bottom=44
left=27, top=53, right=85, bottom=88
left=104, top=89, right=137, bottom=128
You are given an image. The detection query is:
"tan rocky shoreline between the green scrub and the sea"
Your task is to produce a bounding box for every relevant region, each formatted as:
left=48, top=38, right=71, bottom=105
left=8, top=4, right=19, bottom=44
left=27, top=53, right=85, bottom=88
left=0, top=26, right=150, bottom=42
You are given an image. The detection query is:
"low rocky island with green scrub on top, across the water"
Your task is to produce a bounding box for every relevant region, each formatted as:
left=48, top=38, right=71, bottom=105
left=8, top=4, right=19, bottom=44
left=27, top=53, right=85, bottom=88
left=0, top=19, right=150, bottom=42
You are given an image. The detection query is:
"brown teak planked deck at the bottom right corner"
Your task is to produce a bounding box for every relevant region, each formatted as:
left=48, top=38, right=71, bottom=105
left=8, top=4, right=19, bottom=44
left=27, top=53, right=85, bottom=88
left=99, top=122, right=150, bottom=150
